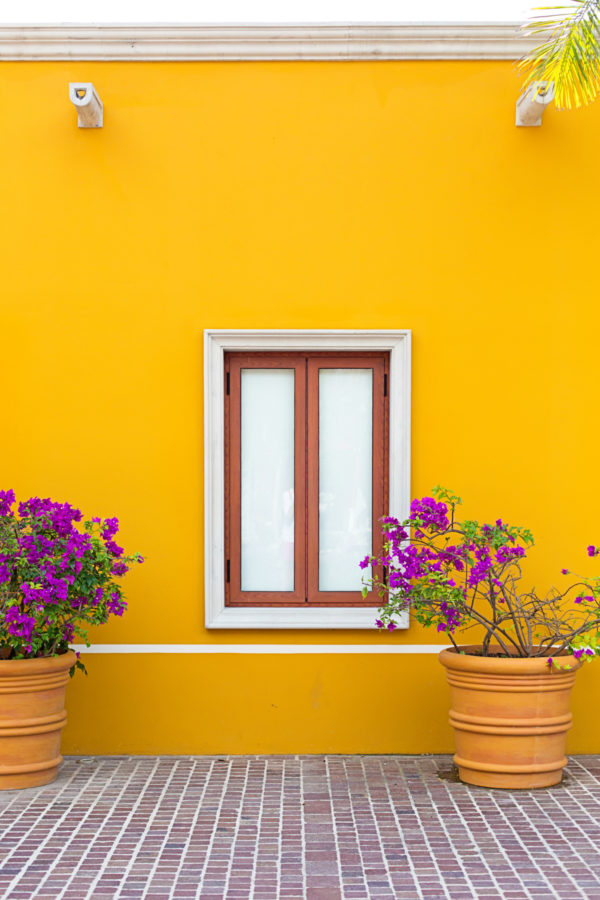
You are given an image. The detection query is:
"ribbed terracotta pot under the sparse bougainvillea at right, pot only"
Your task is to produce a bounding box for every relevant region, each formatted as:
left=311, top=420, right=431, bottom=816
left=439, top=646, right=581, bottom=789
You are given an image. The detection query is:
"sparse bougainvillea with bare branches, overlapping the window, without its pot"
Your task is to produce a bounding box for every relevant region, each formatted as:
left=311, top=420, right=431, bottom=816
left=360, top=487, right=600, bottom=668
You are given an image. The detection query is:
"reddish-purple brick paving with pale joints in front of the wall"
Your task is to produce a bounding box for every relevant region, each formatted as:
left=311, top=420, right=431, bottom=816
left=0, top=756, right=600, bottom=900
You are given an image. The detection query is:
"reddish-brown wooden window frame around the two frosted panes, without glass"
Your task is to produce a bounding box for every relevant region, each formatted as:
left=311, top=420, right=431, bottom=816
left=225, top=352, right=389, bottom=607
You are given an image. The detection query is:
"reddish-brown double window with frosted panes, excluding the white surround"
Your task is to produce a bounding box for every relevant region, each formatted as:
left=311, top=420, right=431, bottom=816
left=225, top=352, right=389, bottom=607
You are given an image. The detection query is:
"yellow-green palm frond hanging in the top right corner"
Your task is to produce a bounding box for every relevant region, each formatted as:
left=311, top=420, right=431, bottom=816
left=518, top=0, right=600, bottom=109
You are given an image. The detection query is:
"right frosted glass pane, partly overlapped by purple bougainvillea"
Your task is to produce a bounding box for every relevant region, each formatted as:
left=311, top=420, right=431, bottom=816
left=319, top=369, right=373, bottom=591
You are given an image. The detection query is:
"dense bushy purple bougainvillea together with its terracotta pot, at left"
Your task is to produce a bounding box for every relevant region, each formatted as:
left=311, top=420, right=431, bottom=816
left=0, top=490, right=143, bottom=790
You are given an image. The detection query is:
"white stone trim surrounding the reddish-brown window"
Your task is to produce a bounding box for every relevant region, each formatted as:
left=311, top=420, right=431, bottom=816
left=204, top=329, right=411, bottom=629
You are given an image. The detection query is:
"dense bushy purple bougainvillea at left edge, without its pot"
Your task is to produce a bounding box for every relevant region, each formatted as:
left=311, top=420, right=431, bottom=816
left=0, top=490, right=144, bottom=669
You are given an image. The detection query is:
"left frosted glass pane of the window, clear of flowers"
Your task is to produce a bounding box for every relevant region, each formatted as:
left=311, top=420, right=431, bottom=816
left=241, top=369, right=294, bottom=591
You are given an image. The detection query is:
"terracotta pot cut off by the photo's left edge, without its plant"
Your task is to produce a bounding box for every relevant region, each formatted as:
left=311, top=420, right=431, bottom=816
left=0, top=652, right=75, bottom=791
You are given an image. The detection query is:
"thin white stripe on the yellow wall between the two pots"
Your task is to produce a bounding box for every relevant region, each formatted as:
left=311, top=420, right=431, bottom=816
left=73, top=644, right=446, bottom=656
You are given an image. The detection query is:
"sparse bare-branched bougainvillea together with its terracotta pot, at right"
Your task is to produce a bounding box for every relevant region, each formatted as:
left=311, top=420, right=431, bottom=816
left=360, top=487, right=600, bottom=788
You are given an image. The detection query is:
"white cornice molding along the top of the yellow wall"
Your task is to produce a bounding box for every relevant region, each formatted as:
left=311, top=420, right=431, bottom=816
left=0, top=22, right=536, bottom=61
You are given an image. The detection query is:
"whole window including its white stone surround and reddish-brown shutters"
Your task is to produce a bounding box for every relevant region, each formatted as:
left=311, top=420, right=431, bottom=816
left=204, top=330, right=410, bottom=629
